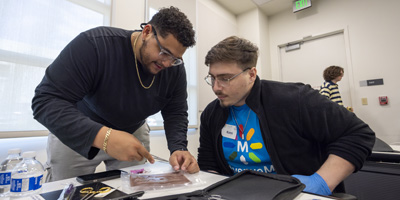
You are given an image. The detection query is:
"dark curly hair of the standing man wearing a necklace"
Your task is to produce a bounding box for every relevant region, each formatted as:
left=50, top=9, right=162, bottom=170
left=148, top=6, right=196, bottom=47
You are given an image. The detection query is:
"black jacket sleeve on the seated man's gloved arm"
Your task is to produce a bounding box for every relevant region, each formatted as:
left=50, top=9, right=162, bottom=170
left=299, top=85, right=375, bottom=171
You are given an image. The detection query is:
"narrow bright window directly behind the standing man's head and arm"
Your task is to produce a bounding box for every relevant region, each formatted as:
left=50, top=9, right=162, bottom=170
left=146, top=3, right=198, bottom=130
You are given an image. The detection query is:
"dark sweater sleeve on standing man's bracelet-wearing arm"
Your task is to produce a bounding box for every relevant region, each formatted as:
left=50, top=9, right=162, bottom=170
left=32, top=33, right=102, bottom=158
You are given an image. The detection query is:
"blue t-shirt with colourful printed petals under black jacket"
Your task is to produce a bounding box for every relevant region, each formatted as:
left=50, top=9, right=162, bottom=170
left=221, top=104, right=276, bottom=174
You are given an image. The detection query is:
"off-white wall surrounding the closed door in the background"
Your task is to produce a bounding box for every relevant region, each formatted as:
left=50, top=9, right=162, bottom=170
left=268, top=0, right=400, bottom=144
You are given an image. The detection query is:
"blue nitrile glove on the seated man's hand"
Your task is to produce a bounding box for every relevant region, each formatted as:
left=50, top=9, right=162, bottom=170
left=292, top=172, right=332, bottom=196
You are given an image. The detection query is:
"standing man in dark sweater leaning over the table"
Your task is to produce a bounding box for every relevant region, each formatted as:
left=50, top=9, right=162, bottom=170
left=32, top=7, right=199, bottom=181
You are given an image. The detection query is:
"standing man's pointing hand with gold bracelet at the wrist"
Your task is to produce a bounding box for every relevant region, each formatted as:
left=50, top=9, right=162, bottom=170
left=107, top=130, right=154, bottom=163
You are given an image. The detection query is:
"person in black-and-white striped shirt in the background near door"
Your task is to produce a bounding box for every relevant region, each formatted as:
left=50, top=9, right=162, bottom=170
left=319, top=65, right=344, bottom=106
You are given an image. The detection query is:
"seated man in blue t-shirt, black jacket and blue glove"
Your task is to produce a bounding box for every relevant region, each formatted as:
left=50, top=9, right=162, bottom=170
left=198, top=36, right=375, bottom=195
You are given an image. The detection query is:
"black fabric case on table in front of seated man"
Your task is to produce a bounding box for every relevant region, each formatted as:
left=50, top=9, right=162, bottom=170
left=144, top=170, right=305, bottom=200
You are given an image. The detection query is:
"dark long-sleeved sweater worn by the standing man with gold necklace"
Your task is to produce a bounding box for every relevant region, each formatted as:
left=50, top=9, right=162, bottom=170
left=32, top=27, right=188, bottom=159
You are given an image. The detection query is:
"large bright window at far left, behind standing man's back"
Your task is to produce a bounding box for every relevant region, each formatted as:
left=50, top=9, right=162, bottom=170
left=0, top=0, right=111, bottom=132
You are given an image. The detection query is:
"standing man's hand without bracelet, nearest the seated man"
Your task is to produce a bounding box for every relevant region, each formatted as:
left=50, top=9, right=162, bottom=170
left=169, top=150, right=200, bottom=174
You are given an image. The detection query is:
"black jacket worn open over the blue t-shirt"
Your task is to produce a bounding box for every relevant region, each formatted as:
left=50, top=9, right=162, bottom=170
left=198, top=77, right=375, bottom=178
